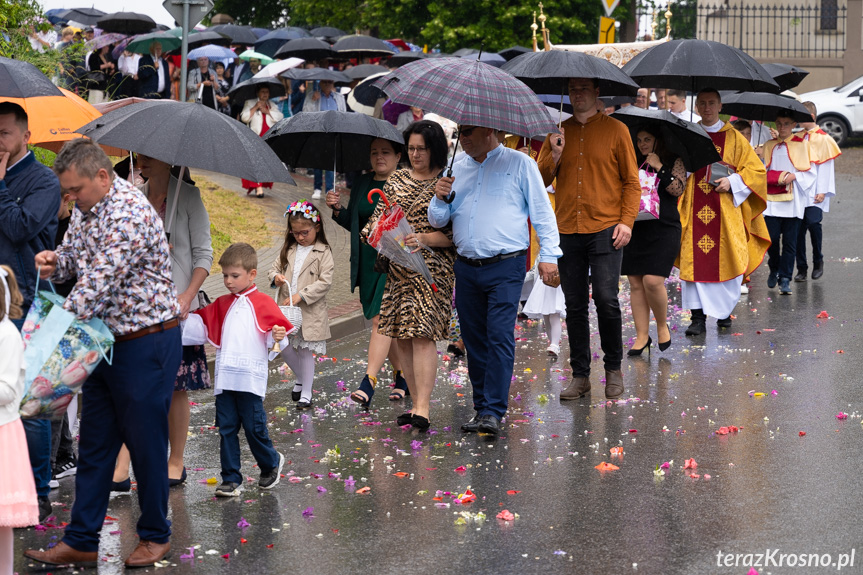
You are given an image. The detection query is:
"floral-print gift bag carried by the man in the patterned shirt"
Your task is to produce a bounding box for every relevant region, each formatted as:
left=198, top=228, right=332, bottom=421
left=20, top=291, right=114, bottom=419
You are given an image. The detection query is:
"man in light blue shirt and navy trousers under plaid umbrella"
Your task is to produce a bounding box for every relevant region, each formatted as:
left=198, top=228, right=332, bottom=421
left=428, top=126, right=561, bottom=435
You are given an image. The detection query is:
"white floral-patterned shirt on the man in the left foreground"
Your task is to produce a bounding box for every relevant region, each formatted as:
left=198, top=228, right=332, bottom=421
left=51, top=177, right=180, bottom=335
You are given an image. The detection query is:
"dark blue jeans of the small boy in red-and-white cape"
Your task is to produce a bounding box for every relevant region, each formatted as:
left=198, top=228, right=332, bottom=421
left=216, top=390, right=279, bottom=485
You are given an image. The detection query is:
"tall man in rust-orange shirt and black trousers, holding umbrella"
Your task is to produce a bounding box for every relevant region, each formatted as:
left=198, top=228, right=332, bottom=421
left=537, top=78, right=641, bottom=400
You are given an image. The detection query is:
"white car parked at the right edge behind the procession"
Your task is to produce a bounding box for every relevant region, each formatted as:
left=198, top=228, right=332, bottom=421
left=800, top=77, right=863, bottom=146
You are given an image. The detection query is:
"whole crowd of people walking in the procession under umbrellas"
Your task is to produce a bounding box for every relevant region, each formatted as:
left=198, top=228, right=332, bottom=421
left=0, top=18, right=839, bottom=572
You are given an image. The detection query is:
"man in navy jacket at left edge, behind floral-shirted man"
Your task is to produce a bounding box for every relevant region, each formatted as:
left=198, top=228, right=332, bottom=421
left=0, top=102, right=60, bottom=519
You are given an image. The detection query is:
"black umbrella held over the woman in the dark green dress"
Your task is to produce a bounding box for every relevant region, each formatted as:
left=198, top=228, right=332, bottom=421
left=264, top=110, right=404, bottom=172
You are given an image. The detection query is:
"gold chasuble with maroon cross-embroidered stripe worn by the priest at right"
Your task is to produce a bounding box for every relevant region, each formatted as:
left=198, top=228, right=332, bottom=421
left=675, top=123, right=770, bottom=282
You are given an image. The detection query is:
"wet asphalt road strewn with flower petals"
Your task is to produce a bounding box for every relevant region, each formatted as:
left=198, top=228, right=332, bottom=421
left=15, top=174, right=863, bottom=575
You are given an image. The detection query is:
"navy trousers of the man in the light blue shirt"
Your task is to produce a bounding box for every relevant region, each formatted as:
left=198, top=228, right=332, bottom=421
left=455, top=256, right=527, bottom=419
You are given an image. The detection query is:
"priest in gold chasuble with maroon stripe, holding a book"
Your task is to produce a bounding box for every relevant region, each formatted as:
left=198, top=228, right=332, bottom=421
left=675, top=88, right=770, bottom=335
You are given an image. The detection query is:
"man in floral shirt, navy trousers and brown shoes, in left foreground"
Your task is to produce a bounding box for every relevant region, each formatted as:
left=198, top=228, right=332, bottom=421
left=25, top=138, right=182, bottom=567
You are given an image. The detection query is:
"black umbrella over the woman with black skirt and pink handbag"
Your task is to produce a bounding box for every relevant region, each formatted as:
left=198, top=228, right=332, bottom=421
left=611, top=106, right=722, bottom=172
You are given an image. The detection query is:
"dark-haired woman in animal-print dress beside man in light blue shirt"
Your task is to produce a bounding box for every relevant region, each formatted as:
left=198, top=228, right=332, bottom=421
left=360, top=120, right=455, bottom=430
